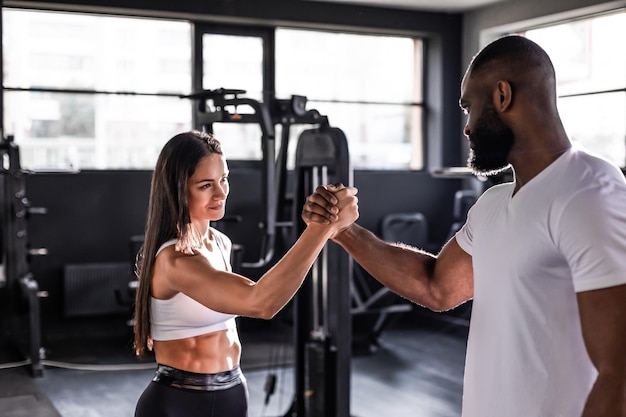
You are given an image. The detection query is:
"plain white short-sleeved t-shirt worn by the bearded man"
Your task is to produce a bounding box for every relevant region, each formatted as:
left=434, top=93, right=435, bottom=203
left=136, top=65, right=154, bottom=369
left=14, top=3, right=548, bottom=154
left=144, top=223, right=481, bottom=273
left=456, top=144, right=626, bottom=417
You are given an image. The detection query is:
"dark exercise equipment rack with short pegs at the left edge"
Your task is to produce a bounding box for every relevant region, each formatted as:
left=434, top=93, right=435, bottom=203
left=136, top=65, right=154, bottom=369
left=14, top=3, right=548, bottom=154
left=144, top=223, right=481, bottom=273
left=0, top=136, right=47, bottom=377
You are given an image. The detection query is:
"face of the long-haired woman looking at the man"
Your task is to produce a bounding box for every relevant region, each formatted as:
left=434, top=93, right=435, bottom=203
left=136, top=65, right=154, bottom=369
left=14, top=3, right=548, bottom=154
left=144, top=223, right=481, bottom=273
left=187, top=153, right=230, bottom=221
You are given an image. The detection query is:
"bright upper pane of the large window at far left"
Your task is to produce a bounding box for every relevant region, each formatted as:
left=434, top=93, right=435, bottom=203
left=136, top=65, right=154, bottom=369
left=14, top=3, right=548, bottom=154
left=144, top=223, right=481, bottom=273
left=3, top=9, right=191, bottom=94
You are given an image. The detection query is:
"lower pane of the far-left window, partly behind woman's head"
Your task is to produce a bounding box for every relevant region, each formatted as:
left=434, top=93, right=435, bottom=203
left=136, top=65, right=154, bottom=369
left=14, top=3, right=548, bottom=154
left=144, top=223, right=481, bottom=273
left=4, top=91, right=191, bottom=169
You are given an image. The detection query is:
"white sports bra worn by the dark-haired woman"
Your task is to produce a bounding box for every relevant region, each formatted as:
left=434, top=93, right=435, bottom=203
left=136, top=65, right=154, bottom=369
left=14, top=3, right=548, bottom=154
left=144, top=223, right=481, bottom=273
left=150, top=229, right=237, bottom=340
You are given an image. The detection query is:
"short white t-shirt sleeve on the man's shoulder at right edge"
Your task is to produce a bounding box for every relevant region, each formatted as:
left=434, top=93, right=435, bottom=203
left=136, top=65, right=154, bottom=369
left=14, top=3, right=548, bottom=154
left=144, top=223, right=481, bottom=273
left=557, top=181, right=626, bottom=292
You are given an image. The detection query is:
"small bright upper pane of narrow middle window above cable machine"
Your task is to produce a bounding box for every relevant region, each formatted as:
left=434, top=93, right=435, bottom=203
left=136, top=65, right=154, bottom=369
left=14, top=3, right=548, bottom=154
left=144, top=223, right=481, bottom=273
left=202, top=34, right=263, bottom=100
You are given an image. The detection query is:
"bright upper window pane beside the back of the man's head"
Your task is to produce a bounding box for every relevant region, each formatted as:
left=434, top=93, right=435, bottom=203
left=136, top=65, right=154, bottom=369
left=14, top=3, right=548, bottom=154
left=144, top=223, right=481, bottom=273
left=526, top=12, right=626, bottom=95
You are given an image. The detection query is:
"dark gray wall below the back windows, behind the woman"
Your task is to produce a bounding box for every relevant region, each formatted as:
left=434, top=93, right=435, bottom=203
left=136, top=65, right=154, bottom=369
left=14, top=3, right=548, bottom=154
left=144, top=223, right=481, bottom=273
left=26, top=168, right=460, bottom=339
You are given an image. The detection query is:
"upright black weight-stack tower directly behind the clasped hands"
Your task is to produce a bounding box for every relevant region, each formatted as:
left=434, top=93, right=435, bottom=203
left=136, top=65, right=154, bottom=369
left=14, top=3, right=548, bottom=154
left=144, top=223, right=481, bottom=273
left=287, top=124, right=353, bottom=417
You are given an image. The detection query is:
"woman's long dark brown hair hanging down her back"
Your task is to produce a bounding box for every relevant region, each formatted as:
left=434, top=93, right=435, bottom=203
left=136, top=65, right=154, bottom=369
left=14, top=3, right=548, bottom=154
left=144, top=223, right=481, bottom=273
left=134, top=130, right=222, bottom=358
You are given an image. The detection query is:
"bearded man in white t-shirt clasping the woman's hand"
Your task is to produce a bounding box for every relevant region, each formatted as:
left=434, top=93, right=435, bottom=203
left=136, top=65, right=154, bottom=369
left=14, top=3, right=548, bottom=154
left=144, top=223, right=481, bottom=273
left=302, top=36, right=626, bottom=417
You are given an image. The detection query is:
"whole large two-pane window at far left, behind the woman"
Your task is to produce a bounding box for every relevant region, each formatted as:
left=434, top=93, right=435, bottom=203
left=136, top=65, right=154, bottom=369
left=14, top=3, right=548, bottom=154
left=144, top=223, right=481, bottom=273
left=3, top=9, right=191, bottom=169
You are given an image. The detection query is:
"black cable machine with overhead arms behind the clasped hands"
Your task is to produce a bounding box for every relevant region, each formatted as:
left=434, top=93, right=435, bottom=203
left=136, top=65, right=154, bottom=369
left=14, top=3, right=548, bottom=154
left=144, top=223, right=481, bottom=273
left=186, top=89, right=352, bottom=417
